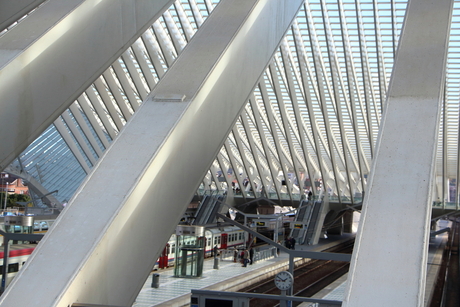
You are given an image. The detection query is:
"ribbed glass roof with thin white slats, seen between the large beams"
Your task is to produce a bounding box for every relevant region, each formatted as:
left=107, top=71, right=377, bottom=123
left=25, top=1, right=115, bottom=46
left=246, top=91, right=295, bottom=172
left=0, top=0, right=460, bottom=207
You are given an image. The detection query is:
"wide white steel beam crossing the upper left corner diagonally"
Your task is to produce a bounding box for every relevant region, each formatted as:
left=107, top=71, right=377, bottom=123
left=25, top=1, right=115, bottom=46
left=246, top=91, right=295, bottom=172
left=0, top=0, right=173, bottom=169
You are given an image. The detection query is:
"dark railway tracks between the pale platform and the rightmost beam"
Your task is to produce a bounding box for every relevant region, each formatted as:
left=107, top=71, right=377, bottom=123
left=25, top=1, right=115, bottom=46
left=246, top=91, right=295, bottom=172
left=238, top=240, right=354, bottom=307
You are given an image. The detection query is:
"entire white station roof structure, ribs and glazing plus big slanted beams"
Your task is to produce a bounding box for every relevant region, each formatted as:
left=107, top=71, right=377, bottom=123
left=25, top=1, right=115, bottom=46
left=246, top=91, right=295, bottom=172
left=0, top=0, right=452, bottom=306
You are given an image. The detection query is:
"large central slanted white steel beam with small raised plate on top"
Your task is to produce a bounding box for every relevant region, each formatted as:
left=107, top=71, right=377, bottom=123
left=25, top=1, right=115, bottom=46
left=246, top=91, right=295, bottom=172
left=0, top=0, right=303, bottom=306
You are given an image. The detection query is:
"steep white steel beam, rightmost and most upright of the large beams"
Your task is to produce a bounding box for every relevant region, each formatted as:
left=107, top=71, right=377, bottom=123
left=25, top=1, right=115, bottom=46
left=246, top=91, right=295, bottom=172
left=343, top=0, right=453, bottom=307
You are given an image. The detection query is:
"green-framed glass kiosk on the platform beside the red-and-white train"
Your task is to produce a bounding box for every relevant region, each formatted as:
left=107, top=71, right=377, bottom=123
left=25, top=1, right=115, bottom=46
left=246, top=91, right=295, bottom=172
left=174, top=225, right=206, bottom=278
